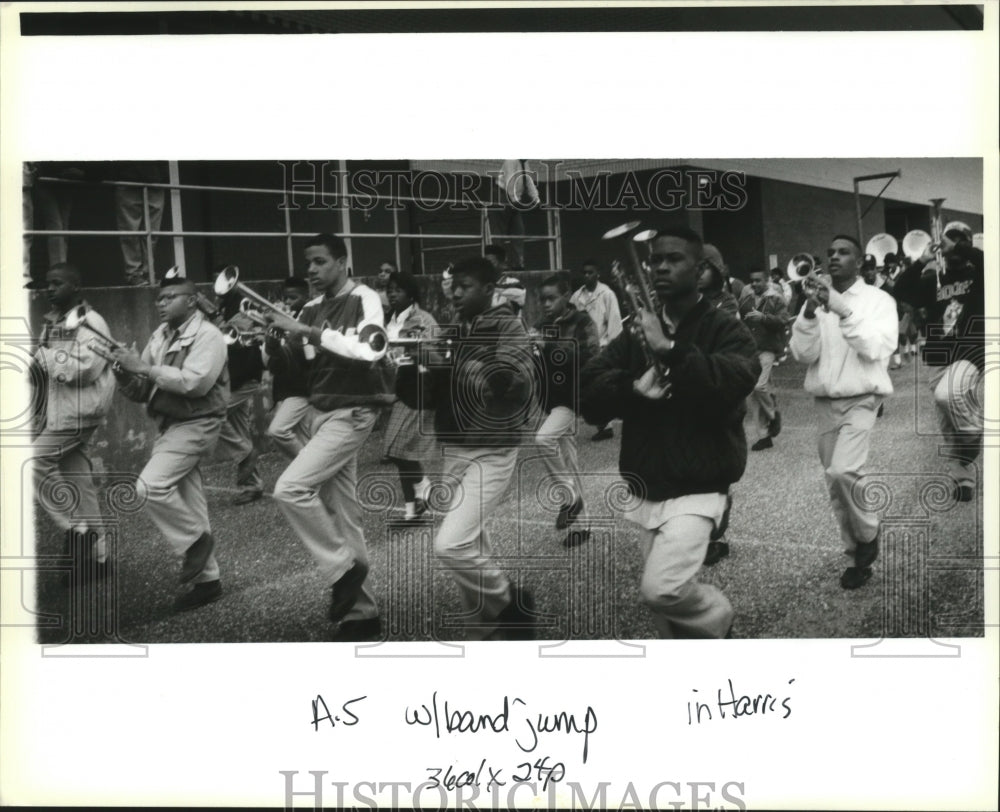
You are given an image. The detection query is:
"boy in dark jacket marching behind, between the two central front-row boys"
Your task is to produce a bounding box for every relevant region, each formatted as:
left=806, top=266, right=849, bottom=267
left=535, top=275, right=600, bottom=547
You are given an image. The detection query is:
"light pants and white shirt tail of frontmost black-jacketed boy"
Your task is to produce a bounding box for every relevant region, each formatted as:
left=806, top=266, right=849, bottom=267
left=629, top=493, right=733, bottom=638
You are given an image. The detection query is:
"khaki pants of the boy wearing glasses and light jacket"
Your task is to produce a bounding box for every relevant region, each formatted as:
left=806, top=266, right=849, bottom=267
left=138, top=417, right=222, bottom=583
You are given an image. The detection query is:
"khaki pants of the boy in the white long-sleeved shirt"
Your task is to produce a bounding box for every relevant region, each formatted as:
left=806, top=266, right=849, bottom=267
left=816, top=395, right=885, bottom=555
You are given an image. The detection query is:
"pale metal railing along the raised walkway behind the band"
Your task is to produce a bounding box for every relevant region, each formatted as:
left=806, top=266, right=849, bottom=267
left=23, top=177, right=562, bottom=284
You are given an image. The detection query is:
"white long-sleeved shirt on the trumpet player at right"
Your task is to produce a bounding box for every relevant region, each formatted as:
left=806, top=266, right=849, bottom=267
left=789, top=277, right=899, bottom=398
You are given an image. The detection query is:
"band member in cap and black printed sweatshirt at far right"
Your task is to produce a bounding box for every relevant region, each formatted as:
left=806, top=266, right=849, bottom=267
left=895, top=222, right=986, bottom=502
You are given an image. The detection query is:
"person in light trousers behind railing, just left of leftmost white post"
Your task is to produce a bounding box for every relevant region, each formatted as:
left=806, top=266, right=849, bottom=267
left=113, top=161, right=169, bottom=285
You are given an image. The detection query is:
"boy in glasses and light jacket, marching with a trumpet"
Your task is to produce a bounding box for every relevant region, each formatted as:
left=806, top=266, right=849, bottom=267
left=114, top=276, right=229, bottom=612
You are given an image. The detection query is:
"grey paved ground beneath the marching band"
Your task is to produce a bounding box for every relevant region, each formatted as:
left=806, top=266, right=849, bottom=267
left=38, top=356, right=983, bottom=643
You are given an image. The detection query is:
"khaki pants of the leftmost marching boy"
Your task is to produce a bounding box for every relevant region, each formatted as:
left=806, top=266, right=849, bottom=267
left=33, top=426, right=106, bottom=561
